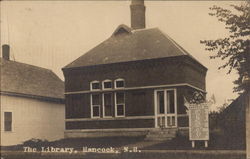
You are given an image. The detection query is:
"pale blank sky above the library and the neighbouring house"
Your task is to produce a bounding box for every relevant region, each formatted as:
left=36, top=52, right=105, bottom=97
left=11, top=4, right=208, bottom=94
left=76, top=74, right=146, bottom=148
left=0, top=0, right=240, bottom=110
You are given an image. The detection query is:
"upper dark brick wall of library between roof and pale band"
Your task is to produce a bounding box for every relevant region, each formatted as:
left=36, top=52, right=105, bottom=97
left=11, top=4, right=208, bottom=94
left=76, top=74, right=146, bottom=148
left=63, top=56, right=206, bottom=92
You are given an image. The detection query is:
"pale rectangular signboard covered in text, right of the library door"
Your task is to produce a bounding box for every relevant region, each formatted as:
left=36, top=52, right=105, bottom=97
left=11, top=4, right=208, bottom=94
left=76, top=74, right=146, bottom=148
left=188, top=103, right=209, bottom=141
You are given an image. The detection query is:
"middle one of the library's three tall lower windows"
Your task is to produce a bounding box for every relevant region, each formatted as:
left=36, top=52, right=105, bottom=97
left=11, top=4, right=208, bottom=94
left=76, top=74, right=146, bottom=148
left=103, top=93, right=113, bottom=117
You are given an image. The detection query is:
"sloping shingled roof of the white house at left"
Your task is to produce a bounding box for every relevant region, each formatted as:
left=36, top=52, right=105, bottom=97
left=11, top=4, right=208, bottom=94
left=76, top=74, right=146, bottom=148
left=0, top=58, right=64, bottom=99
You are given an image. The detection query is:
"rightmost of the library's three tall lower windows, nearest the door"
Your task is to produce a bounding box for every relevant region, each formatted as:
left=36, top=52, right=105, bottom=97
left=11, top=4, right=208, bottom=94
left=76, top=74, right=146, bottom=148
left=115, top=92, right=125, bottom=117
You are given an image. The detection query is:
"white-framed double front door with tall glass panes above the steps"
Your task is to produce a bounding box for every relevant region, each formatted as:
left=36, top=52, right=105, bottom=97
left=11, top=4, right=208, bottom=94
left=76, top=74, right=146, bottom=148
left=155, top=89, right=177, bottom=128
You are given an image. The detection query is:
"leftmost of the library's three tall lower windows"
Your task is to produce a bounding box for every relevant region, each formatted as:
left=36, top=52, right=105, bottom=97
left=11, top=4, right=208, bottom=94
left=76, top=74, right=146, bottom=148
left=91, top=94, right=101, bottom=118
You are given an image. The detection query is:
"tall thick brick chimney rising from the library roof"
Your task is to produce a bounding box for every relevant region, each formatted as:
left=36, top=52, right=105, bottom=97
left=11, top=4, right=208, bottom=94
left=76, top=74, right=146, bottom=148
left=130, top=0, right=146, bottom=29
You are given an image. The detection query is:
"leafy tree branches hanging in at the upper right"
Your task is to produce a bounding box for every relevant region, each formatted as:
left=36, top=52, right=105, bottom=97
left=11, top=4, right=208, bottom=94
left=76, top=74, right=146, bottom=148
left=200, top=0, right=250, bottom=92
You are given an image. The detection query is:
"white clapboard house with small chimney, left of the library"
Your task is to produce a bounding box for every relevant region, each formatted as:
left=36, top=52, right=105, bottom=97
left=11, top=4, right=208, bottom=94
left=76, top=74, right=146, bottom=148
left=0, top=45, right=65, bottom=146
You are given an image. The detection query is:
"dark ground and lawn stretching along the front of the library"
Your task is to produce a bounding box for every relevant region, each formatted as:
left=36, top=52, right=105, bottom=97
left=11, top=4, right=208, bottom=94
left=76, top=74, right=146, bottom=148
left=1, top=134, right=245, bottom=159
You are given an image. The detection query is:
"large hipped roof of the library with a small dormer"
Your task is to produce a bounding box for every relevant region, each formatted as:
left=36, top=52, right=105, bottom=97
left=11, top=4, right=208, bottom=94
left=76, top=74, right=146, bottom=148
left=64, top=25, right=205, bottom=68
